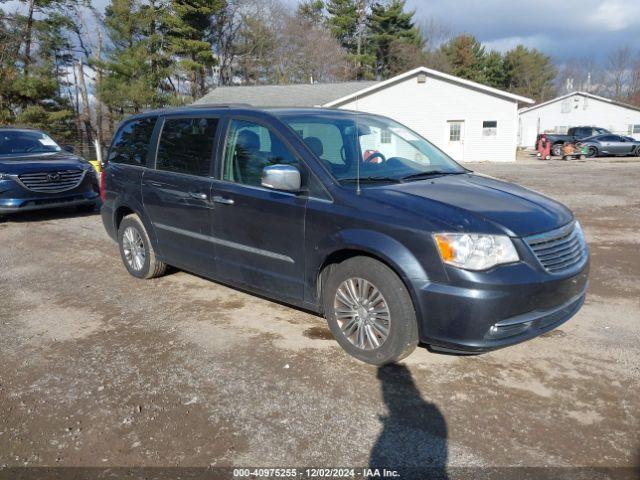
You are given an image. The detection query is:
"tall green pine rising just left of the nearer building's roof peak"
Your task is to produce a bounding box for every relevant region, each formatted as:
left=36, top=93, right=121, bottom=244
left=368, top=0, right=424, bottom=79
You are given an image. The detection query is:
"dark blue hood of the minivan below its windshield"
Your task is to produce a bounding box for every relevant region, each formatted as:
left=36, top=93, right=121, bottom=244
left=367, top=173, right=573, bottom=237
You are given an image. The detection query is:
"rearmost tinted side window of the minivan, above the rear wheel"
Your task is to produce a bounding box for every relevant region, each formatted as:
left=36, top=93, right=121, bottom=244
left=108, top=117, right=156, bottom=167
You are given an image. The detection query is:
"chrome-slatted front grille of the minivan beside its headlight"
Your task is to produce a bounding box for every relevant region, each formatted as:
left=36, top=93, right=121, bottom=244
left=525, top=223, right=587, bottom=273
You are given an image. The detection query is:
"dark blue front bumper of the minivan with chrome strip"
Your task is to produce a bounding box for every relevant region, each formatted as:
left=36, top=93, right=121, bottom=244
left=417, top=261, right=589, bottom=353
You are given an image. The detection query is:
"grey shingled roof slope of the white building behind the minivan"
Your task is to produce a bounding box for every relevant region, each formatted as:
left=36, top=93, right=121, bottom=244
left=195, top=82, right=378, bottom=107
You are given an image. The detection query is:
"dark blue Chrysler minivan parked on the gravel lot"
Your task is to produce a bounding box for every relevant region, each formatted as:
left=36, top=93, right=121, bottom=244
left=102, top=106, right=589, bottom=364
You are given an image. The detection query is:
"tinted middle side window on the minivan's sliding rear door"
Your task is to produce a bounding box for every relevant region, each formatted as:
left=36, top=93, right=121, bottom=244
left=156, top=118, right=218, bottom=177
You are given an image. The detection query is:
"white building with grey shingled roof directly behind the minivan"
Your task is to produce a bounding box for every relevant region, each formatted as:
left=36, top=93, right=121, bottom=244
left=197, top=67, right=534, bottom=162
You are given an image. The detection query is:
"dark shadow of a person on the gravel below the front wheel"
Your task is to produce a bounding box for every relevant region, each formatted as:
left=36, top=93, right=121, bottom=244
left=369, top=364, right=448, bottom=479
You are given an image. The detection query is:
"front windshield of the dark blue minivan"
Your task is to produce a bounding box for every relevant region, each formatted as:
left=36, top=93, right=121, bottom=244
left=281, top=112, right=467, bottom=184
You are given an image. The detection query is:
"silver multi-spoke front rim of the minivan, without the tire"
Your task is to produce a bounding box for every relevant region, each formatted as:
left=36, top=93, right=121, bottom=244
left=333, top=278, right=391, bottom=350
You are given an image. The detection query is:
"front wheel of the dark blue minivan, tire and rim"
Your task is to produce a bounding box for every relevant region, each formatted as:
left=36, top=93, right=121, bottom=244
left=322, top=257, right=418, bottom=365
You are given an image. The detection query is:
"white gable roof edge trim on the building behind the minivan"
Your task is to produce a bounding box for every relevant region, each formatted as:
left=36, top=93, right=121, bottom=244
left=324, top=67, right=535, bottom=107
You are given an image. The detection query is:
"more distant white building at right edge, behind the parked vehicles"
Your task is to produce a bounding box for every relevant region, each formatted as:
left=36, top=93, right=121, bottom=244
left=518, top=92, right=640, bottom=147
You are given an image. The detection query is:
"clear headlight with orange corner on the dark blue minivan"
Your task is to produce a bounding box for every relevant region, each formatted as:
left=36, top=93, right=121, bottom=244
left=433, top=233, right=520, bottom=270
